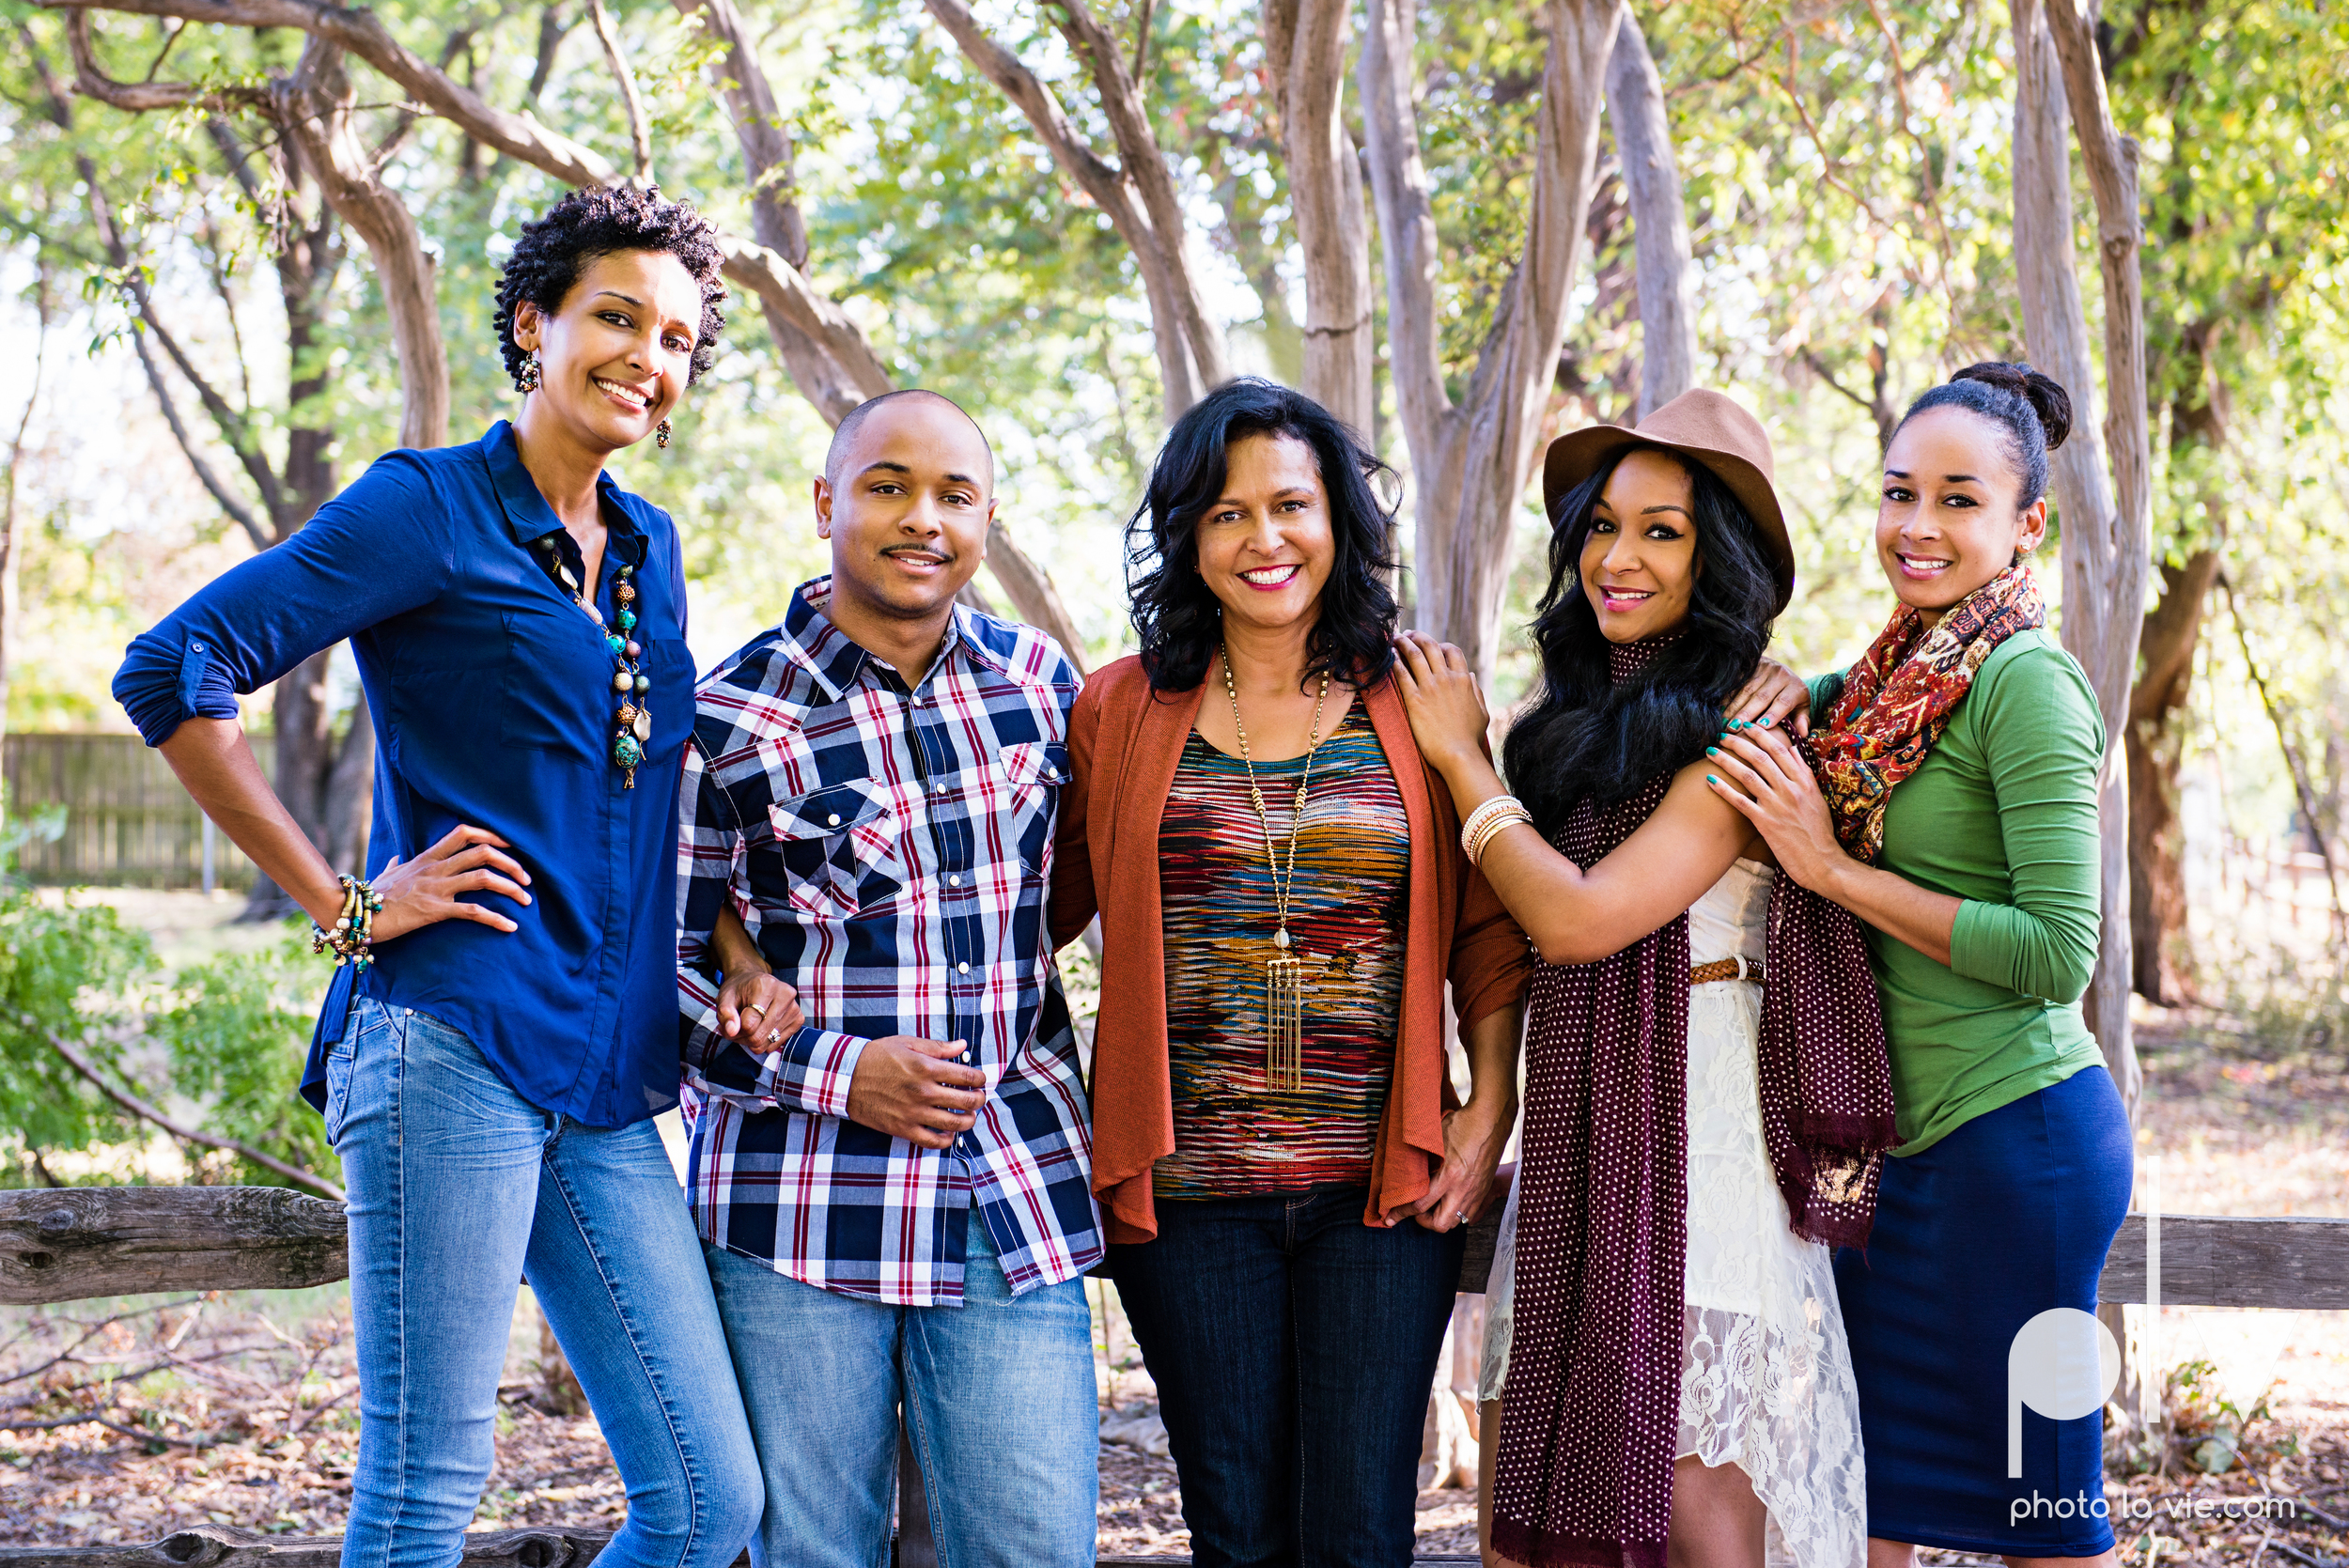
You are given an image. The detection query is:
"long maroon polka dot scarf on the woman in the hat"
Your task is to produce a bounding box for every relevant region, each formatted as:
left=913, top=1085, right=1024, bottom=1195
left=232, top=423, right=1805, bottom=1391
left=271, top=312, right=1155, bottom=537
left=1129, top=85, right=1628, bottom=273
left=1492, top=641, right=1896, bottom=1568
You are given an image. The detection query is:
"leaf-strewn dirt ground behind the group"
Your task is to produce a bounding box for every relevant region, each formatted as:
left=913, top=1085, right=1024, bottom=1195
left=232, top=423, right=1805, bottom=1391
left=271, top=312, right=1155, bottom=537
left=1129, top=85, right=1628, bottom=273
left=0, top=892, right=2349, bottom=1568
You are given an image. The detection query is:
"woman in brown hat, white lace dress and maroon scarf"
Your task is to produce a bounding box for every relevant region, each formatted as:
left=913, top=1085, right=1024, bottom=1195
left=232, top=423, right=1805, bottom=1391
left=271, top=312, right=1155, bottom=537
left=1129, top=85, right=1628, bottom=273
left=1395, top=392, right=1893, bottom=1568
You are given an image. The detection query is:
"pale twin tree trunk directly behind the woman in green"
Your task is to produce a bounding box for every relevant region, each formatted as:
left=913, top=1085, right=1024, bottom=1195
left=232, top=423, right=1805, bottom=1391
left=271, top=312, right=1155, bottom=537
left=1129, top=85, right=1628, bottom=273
left=2014, top=0, right=2152, bottom=1125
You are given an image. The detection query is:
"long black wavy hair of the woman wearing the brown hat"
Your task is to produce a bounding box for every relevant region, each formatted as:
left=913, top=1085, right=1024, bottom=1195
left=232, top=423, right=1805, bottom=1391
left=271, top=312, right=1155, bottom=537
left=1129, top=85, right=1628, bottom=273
left=1501, top=446, right=1779, bottom=838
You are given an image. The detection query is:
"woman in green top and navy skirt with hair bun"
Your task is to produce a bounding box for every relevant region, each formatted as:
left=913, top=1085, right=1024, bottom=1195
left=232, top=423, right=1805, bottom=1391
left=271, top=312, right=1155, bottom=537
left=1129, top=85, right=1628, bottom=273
left=1710, top=364, right=2131, bottom=1568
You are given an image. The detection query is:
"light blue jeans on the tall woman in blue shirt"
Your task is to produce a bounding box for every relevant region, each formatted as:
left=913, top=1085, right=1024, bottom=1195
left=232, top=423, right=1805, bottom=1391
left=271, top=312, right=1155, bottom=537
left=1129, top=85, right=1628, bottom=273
left=327, top=998, right=759, bottom=1568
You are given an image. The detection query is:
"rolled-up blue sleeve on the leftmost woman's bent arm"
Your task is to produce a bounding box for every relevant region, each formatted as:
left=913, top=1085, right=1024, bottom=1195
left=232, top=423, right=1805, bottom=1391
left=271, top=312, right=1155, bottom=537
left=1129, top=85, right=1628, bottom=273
left=113, top=451, right=454, bottom=747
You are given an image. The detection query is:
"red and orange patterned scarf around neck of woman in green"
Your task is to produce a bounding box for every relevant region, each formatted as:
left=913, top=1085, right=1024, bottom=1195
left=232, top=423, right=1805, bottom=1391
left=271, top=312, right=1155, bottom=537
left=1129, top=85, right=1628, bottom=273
left=1812, top=564, right=2048, bottom=866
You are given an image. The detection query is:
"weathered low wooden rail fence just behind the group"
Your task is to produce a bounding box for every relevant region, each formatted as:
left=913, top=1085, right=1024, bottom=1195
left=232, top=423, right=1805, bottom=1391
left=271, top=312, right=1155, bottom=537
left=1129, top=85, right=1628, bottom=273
left=0, top=1188, right=2349, bottom=1568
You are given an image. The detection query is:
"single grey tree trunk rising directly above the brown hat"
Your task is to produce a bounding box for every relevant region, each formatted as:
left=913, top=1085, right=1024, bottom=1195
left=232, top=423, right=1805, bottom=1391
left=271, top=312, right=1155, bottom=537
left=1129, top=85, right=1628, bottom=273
left=1607, top=5, right=1696, bottom=420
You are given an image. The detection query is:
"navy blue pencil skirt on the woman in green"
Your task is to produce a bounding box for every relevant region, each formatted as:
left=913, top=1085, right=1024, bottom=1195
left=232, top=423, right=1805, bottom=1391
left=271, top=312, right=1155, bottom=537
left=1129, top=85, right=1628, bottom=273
left=1835, top=1065, right=2133, bottom=1557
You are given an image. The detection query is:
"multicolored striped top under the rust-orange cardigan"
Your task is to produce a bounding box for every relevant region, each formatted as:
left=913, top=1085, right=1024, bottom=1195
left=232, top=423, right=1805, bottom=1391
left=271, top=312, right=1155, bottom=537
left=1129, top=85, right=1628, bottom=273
left=1154, top=702, right=1412, bottom=1200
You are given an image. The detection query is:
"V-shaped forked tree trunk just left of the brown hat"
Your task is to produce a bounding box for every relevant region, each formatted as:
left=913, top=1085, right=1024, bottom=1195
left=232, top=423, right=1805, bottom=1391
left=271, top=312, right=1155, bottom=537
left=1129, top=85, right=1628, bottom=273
left=1361, top=0, right=1624, bottom=678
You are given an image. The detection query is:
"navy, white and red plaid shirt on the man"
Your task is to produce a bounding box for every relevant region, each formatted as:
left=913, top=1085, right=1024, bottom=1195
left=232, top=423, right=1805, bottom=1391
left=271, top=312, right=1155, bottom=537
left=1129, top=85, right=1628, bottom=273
left=677, top=578, right=1102, bottom=1308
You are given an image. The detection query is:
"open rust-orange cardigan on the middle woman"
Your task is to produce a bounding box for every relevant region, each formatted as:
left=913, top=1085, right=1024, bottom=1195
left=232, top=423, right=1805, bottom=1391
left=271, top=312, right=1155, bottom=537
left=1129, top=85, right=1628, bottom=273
left=1050, top=658, right=1532, bottom=1242
